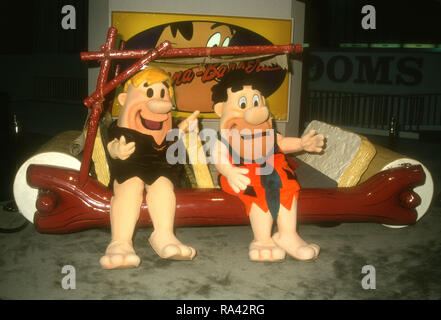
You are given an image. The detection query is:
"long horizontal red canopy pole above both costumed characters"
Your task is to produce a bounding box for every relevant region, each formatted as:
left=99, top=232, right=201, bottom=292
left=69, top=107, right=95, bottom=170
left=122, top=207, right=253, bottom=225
left=80, top=44, right=303, bottom=61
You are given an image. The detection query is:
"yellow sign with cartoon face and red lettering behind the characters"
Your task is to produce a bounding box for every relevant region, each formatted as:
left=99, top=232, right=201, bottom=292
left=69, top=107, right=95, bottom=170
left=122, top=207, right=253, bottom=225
left=112, top=12, right=292, bottom=120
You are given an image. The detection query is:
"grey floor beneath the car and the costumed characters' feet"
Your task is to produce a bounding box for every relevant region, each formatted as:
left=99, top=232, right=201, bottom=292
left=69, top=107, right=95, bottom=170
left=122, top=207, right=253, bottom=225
left=0, top=137, right=441, bottom=300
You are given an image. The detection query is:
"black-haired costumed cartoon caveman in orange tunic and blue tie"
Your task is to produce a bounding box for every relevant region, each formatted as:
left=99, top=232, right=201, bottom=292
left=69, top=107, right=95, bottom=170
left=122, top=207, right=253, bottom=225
left=212, top=69, right=324, bottom=261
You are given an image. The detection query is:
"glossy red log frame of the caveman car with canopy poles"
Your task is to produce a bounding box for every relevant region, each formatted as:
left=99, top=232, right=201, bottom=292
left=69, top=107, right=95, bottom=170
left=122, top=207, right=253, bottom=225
left=14, top=28, right=433, bottom=233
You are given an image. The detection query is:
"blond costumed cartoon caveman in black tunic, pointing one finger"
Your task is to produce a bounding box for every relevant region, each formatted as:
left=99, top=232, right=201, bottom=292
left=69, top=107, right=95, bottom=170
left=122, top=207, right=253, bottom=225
left=100, top=67, right=199, bottom=269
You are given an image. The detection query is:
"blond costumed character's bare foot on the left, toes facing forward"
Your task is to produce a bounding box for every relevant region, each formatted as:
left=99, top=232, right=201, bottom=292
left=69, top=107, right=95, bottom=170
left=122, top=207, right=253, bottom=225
left=100, top=241, right=141, bottom=269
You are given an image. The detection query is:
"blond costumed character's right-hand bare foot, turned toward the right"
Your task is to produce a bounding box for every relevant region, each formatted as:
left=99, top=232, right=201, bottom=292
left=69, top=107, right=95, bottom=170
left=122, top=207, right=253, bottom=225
left=149, top=231, right=196, bottom=260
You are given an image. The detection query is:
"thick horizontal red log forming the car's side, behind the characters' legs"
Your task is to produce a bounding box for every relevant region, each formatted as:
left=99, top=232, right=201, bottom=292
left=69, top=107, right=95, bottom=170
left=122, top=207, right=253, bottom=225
left=28, top=165, right=425, bottom=233
